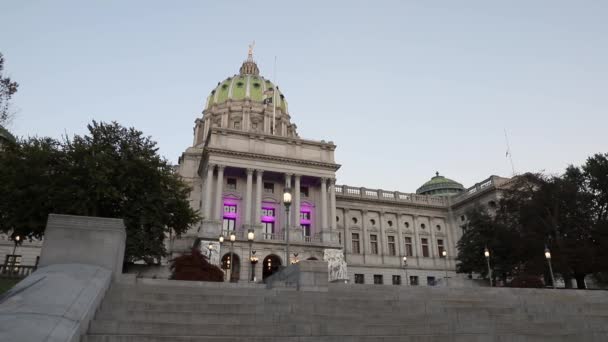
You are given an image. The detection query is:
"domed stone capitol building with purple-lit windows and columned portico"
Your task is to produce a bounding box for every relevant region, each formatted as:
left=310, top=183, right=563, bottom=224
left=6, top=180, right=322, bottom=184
left=170, top=50, right=509, bottom=286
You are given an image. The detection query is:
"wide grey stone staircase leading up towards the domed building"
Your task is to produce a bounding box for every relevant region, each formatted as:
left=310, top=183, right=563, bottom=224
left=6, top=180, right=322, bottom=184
left=83, top=280, right=608, bottom=342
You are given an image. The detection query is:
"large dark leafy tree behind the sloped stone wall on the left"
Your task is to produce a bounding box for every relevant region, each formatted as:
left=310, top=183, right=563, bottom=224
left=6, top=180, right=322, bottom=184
left=0, top=121, right=200, bottom=263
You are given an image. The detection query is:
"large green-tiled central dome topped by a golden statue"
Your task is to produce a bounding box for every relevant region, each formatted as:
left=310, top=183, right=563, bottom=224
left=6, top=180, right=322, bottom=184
left=205, top=59, right=288, bottom=113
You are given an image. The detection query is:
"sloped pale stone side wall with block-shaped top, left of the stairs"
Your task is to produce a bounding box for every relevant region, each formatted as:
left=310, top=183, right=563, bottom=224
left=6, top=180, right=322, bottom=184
left=0, top=214, right=126, bottom=342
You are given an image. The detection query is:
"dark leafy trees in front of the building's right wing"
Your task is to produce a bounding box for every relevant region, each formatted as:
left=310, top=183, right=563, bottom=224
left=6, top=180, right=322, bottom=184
left=457, top=160, right=608, bottom=288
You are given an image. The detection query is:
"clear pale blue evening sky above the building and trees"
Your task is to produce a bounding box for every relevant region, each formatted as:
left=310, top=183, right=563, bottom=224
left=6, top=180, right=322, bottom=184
left=0, top=0, right=608, bottom=192
